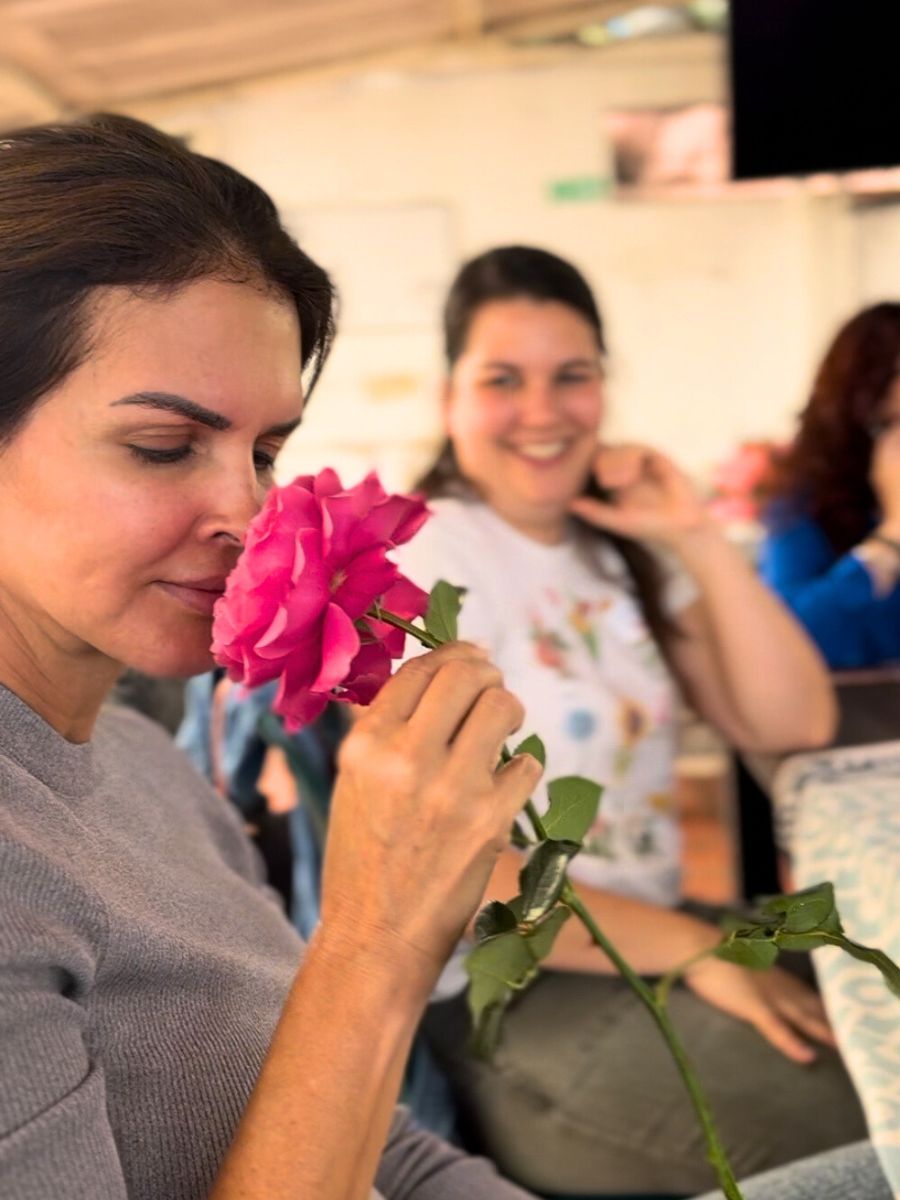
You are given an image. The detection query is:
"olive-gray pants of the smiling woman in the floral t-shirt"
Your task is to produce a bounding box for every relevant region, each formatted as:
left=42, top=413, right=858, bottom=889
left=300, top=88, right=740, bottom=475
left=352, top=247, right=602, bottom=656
left=425, top=972, right=865, bottom=1200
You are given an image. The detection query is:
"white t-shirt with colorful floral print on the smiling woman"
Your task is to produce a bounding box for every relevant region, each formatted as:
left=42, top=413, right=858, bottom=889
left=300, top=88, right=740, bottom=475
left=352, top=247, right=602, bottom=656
left=396, top=499, right=697, bottom=907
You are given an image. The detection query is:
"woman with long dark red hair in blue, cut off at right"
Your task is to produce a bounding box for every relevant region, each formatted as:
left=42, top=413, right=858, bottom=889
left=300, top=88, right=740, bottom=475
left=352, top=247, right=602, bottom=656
left=762, top=304, right=900, bottom=668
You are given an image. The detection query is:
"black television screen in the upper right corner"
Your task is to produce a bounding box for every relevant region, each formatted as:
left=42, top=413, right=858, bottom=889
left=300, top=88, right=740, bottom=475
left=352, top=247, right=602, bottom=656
left=731, top=0, right=900, bottom=179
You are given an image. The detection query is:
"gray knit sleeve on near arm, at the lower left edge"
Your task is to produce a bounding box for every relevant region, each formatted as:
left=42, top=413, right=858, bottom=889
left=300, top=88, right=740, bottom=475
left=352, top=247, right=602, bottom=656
left=0, top=840, right=127, bottom=1200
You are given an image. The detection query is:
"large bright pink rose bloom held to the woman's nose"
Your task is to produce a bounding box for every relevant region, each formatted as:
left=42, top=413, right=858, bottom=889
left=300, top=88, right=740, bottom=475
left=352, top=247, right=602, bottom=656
left=212, top=469, right=428, bottom=730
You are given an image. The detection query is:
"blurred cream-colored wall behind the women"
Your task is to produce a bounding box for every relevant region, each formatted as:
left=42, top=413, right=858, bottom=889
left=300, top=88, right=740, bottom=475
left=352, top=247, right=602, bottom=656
left=138, top=38, right=900, bottom=485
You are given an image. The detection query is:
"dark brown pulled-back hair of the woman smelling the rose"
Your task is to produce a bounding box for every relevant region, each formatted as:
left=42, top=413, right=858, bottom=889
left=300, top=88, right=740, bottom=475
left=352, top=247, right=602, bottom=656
left=0, top=113, right=334, bottom=445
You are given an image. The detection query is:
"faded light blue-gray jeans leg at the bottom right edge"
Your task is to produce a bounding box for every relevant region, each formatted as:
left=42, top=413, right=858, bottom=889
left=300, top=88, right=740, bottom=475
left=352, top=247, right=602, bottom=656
left=701, top=1142, right=893, bottom=1200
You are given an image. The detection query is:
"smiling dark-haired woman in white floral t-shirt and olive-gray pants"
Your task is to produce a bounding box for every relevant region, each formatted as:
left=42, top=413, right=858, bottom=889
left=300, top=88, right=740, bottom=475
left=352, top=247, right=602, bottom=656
left=397, top=246, right=864, bottom=1193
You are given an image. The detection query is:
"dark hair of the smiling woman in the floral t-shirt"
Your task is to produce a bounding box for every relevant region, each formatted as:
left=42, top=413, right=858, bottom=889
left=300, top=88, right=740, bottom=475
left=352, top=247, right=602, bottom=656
left=419, top=246, right=676, bottom=646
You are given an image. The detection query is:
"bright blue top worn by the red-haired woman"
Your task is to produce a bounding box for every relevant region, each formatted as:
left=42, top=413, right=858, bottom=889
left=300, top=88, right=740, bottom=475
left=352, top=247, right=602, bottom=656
left=760, top=511, right=900, bottom=670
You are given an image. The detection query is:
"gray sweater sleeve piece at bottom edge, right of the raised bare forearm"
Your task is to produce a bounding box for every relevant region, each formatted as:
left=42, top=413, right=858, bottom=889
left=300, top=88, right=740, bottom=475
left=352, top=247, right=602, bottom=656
left=376, top=1109, right=540, bottom=1200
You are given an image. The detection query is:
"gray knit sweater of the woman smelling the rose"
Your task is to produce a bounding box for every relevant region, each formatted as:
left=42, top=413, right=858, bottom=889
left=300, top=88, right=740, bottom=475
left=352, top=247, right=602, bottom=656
left=0, top=686, right=532, bottom=1200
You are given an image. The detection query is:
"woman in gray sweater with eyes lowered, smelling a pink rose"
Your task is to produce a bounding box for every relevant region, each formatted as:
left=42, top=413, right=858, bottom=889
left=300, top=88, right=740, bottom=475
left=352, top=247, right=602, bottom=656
left=0, top=116, right=892, bottom=1200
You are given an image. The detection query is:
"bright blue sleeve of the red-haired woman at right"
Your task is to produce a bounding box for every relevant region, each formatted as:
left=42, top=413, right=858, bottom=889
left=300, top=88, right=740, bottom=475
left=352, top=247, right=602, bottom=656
left=760, top=520, right=878, bottom=668
